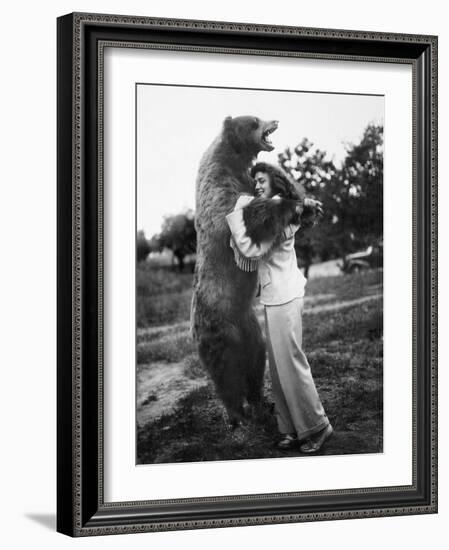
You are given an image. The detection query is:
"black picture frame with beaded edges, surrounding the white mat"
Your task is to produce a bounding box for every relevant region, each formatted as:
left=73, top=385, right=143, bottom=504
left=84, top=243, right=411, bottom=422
left=57, top=13, right=437, bottom=536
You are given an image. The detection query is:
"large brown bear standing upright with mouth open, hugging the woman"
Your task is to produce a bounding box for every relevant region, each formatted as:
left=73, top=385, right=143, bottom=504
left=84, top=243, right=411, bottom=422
left=191, top=116, right=303, bottom=427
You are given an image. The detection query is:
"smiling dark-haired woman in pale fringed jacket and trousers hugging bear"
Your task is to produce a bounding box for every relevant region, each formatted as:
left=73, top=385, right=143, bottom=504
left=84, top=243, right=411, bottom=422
left=226, top=163, right=333, bottom=454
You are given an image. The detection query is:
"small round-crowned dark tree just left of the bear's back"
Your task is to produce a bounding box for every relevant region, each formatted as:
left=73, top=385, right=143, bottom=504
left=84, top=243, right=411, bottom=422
left=158, top=210, right=196, bottom=271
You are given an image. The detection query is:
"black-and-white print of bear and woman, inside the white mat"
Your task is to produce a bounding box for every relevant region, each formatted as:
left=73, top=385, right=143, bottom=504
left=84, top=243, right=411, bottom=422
left=135, top=82, right=384, bottom=464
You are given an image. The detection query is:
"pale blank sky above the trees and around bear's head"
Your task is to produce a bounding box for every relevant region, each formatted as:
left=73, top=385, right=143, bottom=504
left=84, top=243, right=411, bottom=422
left=136, top=84, right=384, bottom=238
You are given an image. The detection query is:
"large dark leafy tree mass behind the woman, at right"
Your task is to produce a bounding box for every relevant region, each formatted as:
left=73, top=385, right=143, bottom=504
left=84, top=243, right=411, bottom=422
left=279, top=124, right=383, bottom=264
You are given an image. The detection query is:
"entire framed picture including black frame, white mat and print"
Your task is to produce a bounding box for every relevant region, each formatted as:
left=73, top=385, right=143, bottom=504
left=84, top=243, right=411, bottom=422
left=57, top=13, right=437, bottom=536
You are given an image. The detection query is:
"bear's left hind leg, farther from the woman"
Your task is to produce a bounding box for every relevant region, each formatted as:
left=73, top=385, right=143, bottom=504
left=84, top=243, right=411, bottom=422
left=198, top=321, right=246, bottom=429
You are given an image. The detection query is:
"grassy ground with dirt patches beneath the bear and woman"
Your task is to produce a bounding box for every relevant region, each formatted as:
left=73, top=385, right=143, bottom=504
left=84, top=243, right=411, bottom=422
left=137, top=262, right=383, bottom=464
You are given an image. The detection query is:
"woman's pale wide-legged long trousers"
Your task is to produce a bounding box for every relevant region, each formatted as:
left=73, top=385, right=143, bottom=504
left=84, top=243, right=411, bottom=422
left=264, top=298, right=329, bottom=439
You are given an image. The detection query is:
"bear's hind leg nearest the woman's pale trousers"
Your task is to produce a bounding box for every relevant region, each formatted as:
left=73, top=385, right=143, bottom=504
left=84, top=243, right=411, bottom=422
left=245, top=312, right=266, bottom=418
